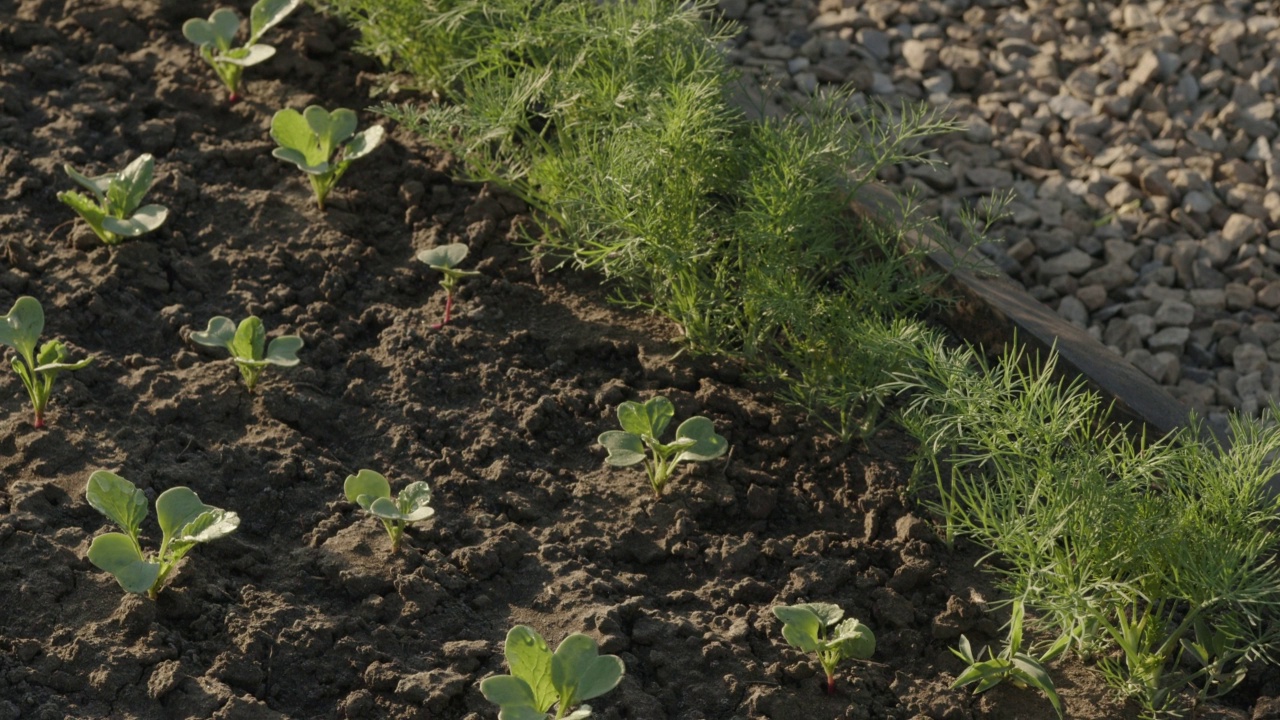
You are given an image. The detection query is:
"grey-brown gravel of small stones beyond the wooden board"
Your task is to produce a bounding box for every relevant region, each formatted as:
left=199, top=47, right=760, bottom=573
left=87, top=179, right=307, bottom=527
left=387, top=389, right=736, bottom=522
left=719, top=0, right=1280, bottom=418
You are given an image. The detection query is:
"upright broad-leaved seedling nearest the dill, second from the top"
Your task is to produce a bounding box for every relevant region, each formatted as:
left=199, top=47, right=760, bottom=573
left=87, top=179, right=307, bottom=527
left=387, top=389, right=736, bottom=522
left=271, top=105, right=383, bottom=210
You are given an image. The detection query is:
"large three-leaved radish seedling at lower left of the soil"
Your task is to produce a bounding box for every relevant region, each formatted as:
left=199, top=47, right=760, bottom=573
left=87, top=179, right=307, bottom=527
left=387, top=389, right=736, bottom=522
left=84, top=470, right=239, bottom=600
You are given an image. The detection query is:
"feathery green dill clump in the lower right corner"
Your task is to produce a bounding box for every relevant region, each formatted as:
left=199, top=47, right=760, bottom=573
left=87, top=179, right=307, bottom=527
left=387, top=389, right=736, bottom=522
left=891, top=345, right=1280, bottom=717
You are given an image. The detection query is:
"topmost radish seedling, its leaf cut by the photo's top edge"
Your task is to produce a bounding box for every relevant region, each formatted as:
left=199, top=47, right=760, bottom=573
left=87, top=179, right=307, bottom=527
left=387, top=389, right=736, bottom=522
left=182, top=0, right=302, bottom=102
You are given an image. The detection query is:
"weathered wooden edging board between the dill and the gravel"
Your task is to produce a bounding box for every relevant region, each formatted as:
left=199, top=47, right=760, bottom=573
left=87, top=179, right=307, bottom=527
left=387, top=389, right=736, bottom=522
left=852, top=183, right=1189, bottom=436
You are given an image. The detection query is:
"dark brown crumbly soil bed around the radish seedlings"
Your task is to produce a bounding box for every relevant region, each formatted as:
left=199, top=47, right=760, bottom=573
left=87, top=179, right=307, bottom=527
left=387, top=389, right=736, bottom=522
left=0, top=0, right=1274, bottom=720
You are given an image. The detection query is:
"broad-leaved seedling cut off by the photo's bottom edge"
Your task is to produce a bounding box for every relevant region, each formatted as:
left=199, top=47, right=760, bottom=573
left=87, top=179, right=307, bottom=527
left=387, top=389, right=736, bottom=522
left=480, top=625, right=625, bottom=720
